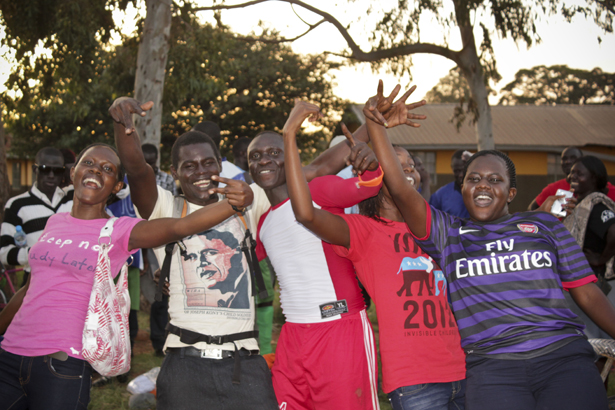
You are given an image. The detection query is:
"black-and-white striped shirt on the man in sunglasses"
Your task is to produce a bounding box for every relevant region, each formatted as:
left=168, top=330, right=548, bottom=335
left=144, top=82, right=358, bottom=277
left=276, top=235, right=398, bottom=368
left=0, top=183, right=74, bottom=265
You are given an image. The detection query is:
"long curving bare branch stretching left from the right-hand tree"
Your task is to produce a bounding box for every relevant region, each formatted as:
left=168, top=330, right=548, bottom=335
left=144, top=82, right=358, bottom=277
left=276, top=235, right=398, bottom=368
left=192, top=0, right=459, bottom=64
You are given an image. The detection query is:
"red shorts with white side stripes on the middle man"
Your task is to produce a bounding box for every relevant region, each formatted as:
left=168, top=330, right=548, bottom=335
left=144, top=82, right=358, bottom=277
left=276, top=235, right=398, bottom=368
left=271, top=310, right=379, bottom=410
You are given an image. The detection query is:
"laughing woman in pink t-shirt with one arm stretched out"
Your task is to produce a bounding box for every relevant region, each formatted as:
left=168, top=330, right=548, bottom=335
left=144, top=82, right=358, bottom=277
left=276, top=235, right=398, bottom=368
left=0, top=143, right=252, bottom=410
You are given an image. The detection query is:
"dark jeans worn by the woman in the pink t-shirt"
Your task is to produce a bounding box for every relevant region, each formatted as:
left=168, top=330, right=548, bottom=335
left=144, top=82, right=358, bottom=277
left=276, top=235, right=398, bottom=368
left=0, top=349, right=92, bottom=410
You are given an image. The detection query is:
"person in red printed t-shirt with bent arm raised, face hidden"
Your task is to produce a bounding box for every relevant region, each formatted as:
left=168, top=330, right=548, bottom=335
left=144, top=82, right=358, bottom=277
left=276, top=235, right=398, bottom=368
left=284, top=94, right=465, bottom=410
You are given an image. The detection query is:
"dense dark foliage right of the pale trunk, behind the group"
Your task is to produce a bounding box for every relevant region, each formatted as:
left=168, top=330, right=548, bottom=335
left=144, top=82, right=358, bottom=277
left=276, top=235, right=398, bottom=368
left=162, top=16, right=343, bottom=160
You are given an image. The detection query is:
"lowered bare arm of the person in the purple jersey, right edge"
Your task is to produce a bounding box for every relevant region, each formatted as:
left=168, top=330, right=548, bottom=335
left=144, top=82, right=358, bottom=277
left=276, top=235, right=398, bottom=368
left=570, top=283, right=615, bottom=339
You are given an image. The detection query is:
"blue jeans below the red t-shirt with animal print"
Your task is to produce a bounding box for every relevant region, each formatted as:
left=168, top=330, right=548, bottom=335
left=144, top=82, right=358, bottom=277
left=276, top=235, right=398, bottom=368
left=388, top=379, right=466, bottom=410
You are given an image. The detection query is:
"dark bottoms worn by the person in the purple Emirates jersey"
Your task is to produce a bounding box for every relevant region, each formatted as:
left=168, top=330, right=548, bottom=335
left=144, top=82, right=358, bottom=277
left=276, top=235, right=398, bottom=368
left=466, top=337, right=608, bottom=410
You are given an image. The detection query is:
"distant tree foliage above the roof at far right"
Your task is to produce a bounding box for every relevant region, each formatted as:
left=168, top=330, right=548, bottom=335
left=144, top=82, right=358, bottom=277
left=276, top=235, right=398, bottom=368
left=499, top=65, right=615, bottom=105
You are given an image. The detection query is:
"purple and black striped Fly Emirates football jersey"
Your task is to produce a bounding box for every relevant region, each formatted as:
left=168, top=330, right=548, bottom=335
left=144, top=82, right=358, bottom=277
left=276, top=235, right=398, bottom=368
left=417, top=207, right=595, bottom=359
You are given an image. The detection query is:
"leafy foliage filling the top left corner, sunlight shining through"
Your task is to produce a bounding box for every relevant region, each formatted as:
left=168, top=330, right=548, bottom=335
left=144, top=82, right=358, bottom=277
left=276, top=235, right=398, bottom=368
left=0, top=0, right=134, bottom=111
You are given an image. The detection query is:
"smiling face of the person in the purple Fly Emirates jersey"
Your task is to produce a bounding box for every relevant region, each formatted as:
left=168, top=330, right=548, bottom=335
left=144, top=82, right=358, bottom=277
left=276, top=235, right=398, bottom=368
left=461, top=155, right=517, bottom=222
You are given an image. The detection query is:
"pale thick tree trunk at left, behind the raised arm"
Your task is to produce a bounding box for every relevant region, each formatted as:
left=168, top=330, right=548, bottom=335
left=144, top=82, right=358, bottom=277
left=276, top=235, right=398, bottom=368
left=135, top=0, right=171, bottom=152
